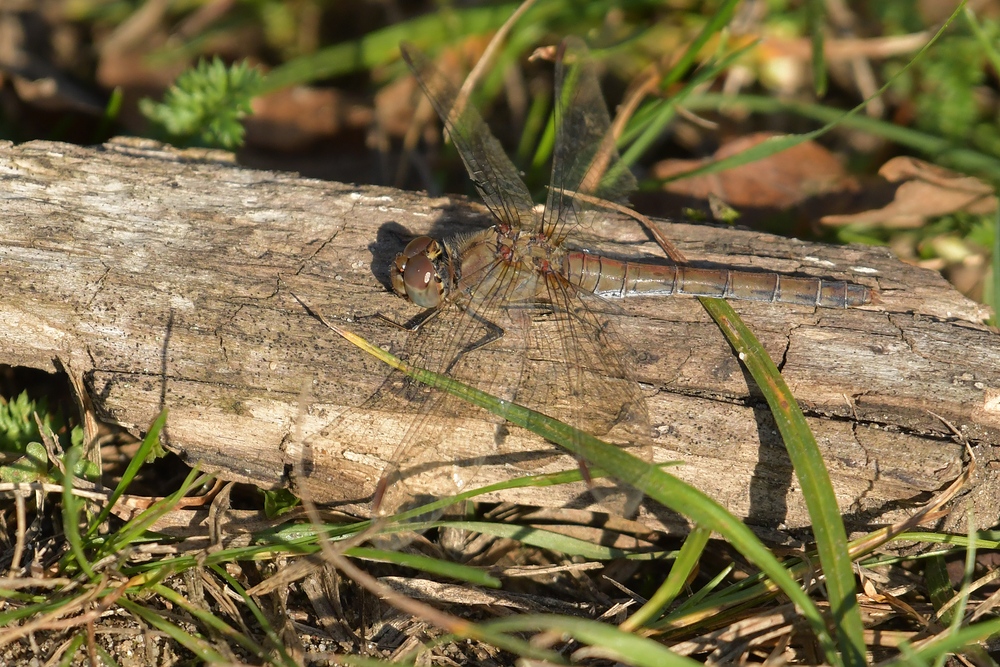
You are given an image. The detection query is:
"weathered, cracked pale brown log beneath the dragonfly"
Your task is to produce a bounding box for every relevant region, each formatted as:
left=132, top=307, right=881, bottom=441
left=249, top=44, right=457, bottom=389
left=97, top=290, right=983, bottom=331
left=0, top=141, right=1000, bottom=528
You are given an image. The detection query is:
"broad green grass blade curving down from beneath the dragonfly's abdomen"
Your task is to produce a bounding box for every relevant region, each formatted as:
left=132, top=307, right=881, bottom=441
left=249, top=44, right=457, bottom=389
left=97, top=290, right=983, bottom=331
left=700, top=298, right=865, bottom=665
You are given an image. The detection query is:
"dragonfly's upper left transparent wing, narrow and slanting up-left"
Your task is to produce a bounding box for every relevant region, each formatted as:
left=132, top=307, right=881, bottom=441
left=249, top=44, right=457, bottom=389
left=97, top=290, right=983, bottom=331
left=399, top=44, right=534, bottom=227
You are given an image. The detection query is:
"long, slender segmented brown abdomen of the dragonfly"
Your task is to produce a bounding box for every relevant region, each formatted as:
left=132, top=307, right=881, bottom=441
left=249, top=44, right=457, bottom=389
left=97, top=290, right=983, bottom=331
left=565, top=252, right=874, bottom=308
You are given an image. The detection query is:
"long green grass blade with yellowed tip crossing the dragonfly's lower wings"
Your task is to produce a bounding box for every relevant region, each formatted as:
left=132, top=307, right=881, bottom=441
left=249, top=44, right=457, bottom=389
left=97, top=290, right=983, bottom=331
left=327, top=322, right=844, bottom=665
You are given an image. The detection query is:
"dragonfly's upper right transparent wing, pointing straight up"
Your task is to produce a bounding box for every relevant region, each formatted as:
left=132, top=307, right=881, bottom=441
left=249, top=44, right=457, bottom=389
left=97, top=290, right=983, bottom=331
left=540, top=37, right=636, bottom=244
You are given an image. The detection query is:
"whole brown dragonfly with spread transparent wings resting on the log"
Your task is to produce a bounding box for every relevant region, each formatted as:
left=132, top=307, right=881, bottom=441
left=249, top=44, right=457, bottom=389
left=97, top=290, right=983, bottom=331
left=330, top=38, right=872, bottom=516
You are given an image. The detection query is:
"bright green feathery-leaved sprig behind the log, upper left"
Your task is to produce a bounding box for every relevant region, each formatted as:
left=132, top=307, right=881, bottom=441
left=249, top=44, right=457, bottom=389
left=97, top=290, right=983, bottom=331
left=139, top=57, right=264, bottom=149
